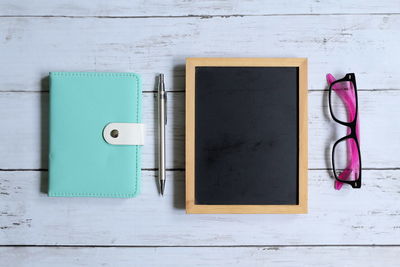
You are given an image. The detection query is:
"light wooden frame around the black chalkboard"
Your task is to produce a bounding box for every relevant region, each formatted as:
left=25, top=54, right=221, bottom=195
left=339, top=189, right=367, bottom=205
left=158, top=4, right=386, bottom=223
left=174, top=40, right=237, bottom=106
left=185, top=58, right=308, bottom=214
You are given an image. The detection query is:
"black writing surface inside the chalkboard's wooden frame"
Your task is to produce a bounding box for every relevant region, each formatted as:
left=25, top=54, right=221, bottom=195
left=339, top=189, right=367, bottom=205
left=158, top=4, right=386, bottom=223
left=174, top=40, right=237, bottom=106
left=195, top=67, right=298, bottom=205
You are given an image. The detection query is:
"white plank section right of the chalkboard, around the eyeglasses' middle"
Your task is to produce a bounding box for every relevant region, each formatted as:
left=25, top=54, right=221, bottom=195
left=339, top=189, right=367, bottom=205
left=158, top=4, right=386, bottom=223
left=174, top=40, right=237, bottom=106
left=308, top=91, right=400, bottom=168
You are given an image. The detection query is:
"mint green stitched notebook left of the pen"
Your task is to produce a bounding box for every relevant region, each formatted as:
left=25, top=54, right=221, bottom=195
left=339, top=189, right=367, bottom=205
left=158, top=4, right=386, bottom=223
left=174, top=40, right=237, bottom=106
left=48, top=72, right=143, bottom=197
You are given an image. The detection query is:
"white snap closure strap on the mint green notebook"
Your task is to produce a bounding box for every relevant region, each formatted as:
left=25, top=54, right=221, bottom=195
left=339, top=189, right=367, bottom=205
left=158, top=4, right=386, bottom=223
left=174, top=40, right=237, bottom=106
left=103, top=123, right=145, bottom=146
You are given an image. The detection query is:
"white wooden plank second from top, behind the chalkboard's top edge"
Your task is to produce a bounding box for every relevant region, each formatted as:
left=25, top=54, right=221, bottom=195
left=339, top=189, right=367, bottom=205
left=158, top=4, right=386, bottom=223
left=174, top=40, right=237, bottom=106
left=0, top=15, right=400, bottom=91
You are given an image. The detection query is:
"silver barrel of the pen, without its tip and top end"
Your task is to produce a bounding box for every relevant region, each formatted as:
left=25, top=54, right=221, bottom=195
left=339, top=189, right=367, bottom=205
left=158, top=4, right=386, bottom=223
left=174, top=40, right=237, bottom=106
left=158, top=84, right=166, bottom=180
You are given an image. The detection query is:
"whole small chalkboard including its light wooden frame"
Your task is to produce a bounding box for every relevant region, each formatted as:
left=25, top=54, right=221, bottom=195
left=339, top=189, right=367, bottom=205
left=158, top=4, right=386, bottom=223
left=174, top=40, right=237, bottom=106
left=186, top=58, right=307, bottom=213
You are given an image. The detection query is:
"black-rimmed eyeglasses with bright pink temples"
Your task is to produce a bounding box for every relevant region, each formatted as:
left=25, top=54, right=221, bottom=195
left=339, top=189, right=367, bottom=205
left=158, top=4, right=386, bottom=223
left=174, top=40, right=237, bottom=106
left=326, top=73, right=361, bottom=190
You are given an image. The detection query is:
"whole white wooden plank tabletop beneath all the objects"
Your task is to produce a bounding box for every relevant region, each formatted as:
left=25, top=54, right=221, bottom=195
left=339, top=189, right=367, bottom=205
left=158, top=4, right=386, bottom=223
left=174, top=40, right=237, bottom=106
left=0, top=0, right=400, bottom=266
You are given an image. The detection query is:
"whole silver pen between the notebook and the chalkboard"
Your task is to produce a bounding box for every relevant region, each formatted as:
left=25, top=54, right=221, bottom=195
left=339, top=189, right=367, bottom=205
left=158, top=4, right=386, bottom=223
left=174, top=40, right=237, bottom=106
left=158, top=74, right=167, bottom=195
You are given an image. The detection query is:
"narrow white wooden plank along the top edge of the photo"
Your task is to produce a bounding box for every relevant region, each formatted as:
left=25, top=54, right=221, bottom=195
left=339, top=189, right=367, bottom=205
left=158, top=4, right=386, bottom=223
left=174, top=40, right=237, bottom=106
left=0, top=0, right=400, bottom=16
